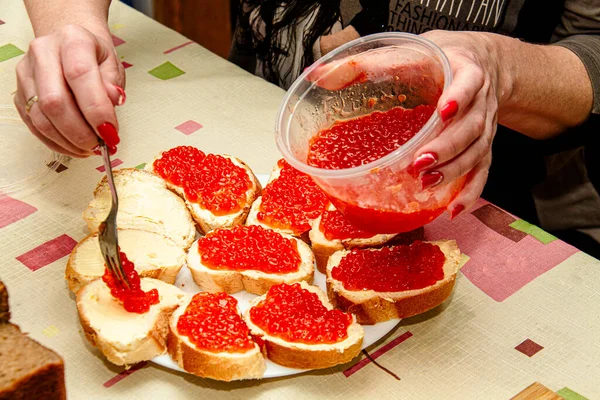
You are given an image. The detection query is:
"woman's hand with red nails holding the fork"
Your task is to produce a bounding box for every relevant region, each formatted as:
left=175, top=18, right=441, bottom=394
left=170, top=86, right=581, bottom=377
left=14, top=25, right=125, bottom=157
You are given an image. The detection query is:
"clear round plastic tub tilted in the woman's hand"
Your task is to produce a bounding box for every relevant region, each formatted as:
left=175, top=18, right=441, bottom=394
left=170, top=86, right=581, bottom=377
left=275, top=33, right=464, bottom=233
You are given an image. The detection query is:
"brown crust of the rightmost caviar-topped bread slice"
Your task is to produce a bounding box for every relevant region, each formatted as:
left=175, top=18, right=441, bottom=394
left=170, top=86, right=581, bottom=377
left=327, top=240, right=460, bottom=325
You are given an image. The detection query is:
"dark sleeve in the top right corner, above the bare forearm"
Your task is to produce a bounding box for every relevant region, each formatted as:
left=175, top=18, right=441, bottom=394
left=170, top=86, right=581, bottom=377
left=552, top=0, right=600, bottom=114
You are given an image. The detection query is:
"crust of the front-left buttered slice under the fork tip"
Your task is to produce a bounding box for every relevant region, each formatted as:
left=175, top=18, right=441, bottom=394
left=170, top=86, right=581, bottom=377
left=77, top=279, right=185, bottom=367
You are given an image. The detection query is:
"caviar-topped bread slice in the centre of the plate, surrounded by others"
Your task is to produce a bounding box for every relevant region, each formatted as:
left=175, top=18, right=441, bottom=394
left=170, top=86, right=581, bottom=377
left=187, top=225, right=314, bottom=295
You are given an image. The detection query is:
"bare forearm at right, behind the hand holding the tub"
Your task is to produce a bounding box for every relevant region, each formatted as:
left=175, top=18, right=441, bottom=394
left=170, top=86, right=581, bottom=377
left=482, top=34, right=593, bottom=139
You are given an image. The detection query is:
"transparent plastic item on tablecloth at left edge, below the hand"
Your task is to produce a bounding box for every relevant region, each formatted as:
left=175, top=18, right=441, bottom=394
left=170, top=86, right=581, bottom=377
left=0, top=105, right=68, bottom=195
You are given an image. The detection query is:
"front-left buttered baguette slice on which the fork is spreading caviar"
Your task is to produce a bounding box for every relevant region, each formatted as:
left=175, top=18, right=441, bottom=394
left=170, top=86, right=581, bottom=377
left=77, top=278, right=187, bottom=365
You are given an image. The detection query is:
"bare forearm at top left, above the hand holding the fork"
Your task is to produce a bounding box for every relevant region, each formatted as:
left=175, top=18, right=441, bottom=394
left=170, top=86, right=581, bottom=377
left=24, top=0, right=111, bottom=37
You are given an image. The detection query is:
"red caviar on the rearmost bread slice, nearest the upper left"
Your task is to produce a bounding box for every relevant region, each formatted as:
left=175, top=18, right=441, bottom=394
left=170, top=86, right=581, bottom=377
left=153, top=146, right=252, bottom=215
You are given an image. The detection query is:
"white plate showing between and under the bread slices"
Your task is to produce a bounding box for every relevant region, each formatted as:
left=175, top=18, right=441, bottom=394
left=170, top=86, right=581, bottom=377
left=150, top=175, right=400, bottom=378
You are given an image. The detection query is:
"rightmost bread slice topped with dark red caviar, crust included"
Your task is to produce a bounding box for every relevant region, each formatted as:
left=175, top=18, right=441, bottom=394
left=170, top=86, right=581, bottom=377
left=327, top=240, right=461, bottom=325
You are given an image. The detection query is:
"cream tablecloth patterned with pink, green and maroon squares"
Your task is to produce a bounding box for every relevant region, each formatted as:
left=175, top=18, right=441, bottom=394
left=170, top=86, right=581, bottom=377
left=0, top=0, right=600, bottom=399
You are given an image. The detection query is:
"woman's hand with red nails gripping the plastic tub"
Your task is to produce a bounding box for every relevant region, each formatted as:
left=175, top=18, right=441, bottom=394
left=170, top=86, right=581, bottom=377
left=308, top=31, right=500, bottom=218
